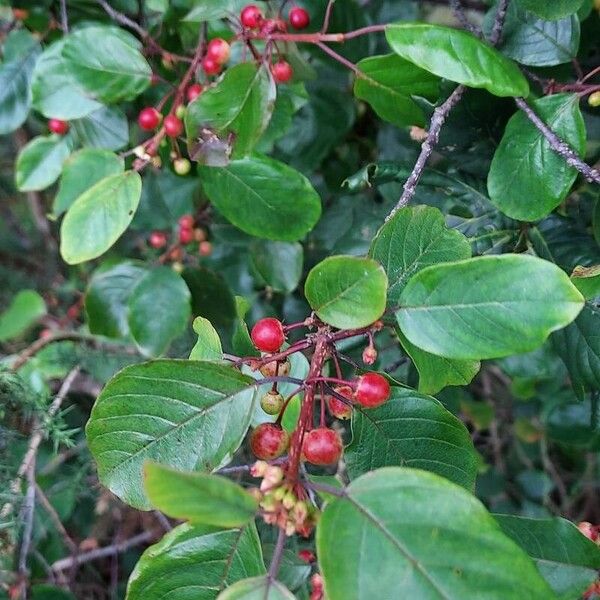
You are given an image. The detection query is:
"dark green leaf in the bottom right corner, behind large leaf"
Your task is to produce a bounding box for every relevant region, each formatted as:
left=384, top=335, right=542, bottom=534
left=494, top=515, right=600, bottom=600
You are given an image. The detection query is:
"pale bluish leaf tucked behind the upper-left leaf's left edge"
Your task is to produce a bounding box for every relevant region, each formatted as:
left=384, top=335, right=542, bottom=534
left=31, top=38, right=102, bottom=121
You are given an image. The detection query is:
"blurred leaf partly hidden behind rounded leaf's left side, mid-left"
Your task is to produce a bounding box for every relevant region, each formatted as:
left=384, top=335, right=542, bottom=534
left=85, top=261, right=147, bottom=337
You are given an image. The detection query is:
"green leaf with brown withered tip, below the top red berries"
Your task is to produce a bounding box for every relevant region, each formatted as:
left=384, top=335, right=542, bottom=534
left=185, top=62, right=277, bottom=158
